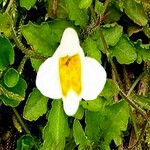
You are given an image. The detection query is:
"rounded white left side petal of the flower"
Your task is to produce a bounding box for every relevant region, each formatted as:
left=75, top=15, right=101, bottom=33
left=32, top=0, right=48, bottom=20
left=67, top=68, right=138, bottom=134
left=36, top=57, right=62, bottom=99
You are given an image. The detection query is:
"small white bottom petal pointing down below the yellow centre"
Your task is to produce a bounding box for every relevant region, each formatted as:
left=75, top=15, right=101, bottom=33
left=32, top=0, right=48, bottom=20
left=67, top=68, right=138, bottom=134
left=63, top=91, right=81, bottom=116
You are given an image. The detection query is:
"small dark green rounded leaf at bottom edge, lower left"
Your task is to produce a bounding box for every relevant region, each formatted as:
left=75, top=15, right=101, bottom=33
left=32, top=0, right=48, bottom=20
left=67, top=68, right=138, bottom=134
left=16, top=135, right=35, bottom=150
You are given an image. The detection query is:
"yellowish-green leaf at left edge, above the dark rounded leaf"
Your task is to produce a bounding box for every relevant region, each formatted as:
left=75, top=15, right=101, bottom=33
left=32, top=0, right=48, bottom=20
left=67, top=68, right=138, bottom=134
left=0, top=13, right=13, bottom=37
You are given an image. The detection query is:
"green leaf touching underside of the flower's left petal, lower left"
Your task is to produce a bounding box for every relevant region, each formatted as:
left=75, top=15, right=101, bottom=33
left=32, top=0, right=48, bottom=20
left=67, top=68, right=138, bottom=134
left=23, top=88, right=48, bottom=121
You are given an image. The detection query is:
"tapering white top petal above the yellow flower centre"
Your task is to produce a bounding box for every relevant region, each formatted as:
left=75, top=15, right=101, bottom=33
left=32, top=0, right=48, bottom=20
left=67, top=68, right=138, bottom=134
left=53, top=28, right=84, bottom=58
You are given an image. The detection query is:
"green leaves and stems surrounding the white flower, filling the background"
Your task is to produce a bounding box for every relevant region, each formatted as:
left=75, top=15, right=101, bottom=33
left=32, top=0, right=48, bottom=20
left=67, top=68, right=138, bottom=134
left=0, top=0, right=150, bottom=150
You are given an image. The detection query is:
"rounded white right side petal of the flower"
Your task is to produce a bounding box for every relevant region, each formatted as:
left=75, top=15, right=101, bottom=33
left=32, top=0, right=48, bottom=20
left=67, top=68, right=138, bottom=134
left=82, top=57, right=106, bottom=100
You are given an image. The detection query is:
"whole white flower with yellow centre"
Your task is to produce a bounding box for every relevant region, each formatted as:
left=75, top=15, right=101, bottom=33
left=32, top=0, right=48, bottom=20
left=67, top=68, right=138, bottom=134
left=36, top=28, right=106, bottom=116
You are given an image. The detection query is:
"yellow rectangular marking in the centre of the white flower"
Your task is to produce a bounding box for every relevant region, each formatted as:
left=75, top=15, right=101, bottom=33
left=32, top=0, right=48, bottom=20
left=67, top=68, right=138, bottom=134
left=59, top=54, right=82, bottom=96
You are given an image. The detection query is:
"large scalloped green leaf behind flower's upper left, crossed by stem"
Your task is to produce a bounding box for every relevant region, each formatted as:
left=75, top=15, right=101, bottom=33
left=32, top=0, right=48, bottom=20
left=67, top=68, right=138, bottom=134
left=21, top=20, right=71, bottom=70
